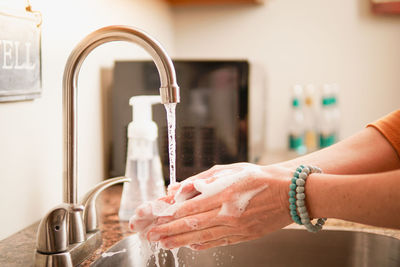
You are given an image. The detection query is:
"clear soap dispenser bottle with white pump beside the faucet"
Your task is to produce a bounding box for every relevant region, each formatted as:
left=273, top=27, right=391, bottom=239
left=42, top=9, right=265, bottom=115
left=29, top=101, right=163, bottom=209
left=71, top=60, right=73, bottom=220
left=118, top=96, right=165, bottom=221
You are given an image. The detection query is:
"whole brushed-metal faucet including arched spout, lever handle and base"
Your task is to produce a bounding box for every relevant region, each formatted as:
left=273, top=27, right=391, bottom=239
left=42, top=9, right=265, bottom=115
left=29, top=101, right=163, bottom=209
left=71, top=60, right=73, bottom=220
left=35, top=26, right=180, bottom=267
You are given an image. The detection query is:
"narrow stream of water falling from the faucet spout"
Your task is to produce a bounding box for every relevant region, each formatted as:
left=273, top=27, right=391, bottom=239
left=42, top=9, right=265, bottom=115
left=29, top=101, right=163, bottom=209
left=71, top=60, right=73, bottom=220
left=164, top=103, right=176, bottom=185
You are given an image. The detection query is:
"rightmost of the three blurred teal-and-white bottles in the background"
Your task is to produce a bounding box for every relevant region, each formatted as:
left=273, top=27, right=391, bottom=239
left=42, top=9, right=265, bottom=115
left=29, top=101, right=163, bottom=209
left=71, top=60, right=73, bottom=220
left=319, top=84, right=336, bottom=148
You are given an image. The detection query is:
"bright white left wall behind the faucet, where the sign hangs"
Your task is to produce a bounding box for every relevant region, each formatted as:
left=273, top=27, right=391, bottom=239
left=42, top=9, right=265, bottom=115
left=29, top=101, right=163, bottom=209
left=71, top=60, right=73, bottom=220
left=0, top=0, right=173, bottom=240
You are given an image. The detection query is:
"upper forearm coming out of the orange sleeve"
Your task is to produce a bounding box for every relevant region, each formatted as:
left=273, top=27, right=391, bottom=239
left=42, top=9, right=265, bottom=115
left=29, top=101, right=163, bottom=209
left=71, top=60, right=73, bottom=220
left=278, top=127, right=400, bottom=174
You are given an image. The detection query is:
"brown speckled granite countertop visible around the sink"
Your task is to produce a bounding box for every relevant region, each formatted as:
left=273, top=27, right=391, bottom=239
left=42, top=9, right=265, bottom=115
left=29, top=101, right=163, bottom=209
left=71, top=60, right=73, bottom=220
left=0, top=185, right=400, bottom=267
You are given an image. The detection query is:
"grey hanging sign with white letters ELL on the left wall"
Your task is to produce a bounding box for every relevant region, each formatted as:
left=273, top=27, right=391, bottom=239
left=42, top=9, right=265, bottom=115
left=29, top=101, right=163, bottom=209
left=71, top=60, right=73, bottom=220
left=0, top=9, right=42, bottom=102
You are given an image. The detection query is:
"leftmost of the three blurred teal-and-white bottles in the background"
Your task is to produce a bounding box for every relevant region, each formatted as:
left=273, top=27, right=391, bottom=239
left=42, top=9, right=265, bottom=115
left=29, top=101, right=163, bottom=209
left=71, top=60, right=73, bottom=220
left=289, top=85, right=307, bottom=154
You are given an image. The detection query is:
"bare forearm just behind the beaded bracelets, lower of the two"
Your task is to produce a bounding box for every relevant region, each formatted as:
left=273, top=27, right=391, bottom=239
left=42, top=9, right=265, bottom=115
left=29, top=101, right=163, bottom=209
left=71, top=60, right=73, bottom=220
left=306, top=170, right=400, bottom=229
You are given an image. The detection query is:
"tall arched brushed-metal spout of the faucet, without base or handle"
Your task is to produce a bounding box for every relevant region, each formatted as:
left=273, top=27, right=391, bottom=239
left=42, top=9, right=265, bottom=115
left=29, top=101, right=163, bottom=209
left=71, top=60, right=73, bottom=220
left=63, top=26, right=179, bottom=204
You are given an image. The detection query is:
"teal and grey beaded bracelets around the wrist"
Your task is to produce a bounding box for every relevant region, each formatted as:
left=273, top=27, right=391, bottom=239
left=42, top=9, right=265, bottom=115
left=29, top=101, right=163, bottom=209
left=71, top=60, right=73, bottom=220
left=289, top=165, right=326, bottom=233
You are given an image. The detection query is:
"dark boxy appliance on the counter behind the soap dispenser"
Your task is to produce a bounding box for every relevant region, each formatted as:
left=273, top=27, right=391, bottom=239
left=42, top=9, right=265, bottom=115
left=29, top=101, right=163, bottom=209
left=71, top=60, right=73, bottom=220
left=110, top=60, right=249, bottom=182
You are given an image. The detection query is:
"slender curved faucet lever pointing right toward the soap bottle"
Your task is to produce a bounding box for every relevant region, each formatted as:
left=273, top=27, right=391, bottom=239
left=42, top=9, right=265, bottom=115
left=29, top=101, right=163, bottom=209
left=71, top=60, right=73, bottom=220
left=80, top=176, right=131, bottom=233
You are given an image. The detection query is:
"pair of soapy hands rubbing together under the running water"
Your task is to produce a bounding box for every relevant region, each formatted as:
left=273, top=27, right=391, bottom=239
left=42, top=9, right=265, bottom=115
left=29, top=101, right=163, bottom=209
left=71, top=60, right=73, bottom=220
left=147, top=163, right=292, bottom=250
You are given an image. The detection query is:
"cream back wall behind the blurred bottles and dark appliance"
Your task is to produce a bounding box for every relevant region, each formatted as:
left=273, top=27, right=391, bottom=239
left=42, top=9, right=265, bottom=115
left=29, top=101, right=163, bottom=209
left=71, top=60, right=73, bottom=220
left=173, top=0, right=400, bottom=149
